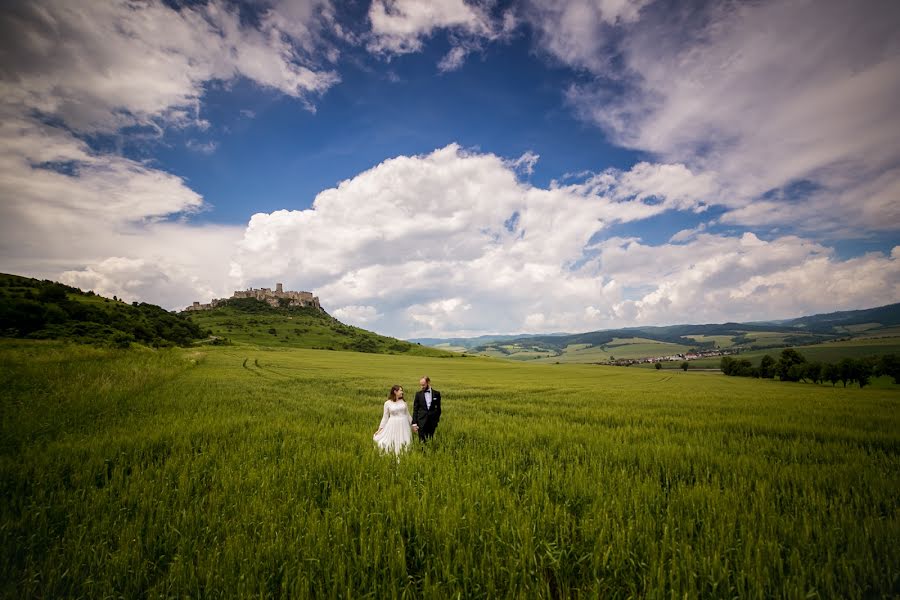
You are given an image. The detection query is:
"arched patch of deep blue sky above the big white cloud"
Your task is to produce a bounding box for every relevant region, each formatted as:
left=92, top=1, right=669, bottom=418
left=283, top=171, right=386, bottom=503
left=151, top=34, right=640, bottom=223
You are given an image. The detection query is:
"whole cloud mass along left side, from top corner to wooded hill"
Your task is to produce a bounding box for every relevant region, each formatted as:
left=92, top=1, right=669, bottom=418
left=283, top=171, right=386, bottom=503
left=0, top=0, right=337, bottom=308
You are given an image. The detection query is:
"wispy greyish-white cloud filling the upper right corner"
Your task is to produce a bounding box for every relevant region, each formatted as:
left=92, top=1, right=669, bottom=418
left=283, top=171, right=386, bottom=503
left=556, top=0, right=900, bottom=235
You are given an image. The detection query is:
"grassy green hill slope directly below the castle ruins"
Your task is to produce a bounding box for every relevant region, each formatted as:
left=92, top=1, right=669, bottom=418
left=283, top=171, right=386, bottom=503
left=182, top=298, right=460, bottom=357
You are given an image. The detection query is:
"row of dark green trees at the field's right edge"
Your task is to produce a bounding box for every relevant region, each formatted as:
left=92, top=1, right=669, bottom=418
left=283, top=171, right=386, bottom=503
left=719, top=348, right=900, bottom=388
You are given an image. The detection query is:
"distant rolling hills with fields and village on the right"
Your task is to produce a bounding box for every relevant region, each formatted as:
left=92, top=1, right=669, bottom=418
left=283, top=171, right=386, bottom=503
left=429, top=304, right=900, bottom=362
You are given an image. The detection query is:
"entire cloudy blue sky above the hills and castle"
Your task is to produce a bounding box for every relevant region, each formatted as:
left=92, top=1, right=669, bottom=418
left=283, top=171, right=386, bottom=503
left=0, top=0, right=900, bottom=338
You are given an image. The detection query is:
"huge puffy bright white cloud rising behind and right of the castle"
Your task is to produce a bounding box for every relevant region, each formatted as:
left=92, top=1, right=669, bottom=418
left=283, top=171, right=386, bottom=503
left=232, top=145, right=900, bottom=337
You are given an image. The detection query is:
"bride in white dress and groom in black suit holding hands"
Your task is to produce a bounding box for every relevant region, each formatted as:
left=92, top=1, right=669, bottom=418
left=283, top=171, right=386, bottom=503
left=372, top=376, right=441, bottom=454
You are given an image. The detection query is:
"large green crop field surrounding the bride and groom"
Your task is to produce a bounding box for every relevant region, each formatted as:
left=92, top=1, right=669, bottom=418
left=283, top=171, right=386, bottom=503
left=0, top=342, right=900, bottom=598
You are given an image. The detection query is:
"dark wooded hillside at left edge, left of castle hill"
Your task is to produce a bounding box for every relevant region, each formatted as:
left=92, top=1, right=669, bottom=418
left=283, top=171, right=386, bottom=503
left=0, top=274, right=203, bottom=347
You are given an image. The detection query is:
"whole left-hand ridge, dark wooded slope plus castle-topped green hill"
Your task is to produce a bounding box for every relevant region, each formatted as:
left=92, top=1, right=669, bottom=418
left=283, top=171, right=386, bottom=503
left=0, top=274, right=460, bottom=357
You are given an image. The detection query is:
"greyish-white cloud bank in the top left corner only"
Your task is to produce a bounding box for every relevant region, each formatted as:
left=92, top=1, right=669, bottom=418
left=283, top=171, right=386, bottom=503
left=0, top=0, right=337, bottom=132
